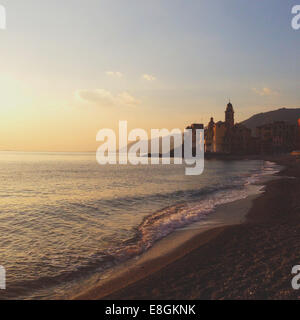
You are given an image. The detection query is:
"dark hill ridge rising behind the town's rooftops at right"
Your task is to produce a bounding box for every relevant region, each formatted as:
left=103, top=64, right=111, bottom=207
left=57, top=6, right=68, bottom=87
left=241, top=108, right=300, bottom=133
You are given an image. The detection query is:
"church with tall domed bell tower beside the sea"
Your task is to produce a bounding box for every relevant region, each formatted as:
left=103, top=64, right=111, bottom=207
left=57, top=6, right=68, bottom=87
left=204, top=102, right=253, bottom=154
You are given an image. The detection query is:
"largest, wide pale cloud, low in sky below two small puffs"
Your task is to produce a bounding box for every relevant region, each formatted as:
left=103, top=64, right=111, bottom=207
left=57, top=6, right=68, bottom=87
left=75, top=89, right=140, bottom=107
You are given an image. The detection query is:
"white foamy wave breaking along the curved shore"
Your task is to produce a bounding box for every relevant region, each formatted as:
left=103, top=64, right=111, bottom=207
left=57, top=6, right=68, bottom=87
left=110, top=161, right=280, bottom=261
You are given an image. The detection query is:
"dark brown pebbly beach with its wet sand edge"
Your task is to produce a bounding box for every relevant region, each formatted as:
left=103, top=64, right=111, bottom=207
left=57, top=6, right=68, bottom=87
left=74, top=156, right=300, bottom=300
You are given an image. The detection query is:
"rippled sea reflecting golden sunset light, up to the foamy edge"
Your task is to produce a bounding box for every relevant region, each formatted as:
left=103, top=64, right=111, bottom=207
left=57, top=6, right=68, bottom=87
left=0, top=152, right=276, bottom=298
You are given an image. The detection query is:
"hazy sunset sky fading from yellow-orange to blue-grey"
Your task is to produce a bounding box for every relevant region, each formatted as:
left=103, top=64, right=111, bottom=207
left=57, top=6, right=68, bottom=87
left=0, top=0, right=300, bottom=151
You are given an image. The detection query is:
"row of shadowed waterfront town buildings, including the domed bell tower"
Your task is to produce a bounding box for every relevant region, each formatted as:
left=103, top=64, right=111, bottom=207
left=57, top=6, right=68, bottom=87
left=187, top=102, right=300, bottom=155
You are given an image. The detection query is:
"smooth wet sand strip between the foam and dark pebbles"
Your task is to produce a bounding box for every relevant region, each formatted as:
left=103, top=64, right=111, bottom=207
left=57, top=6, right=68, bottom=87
left=73, top=158, right=280, bottom=300
